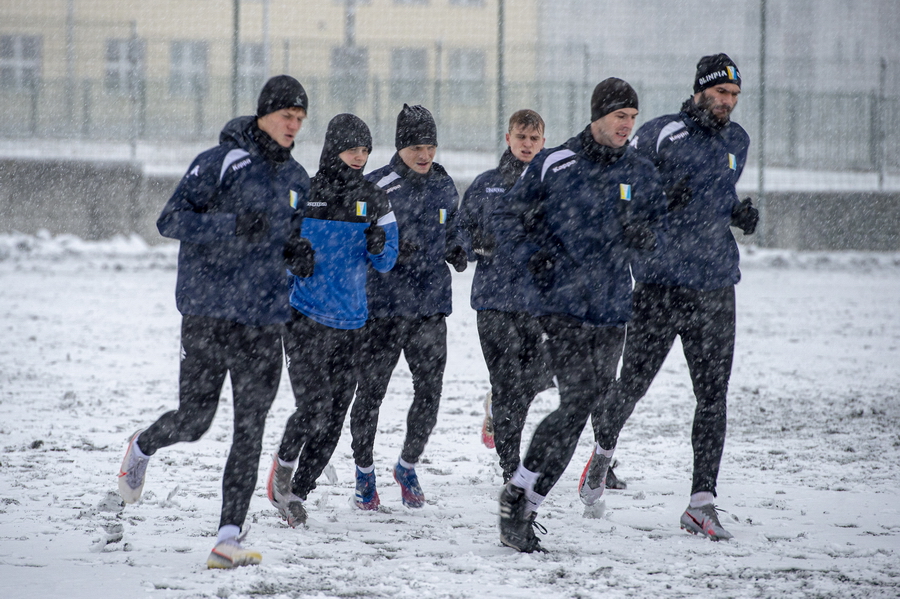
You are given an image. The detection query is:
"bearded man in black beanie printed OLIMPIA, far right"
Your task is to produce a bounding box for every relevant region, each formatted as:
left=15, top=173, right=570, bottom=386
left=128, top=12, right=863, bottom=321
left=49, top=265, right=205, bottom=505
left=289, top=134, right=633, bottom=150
left=580, top=54, right=759, bottom=541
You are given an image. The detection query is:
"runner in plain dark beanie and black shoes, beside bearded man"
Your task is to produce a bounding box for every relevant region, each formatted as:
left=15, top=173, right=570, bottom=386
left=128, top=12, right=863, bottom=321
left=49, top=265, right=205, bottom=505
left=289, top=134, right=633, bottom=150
left=494, top=77, right=665, bottom=553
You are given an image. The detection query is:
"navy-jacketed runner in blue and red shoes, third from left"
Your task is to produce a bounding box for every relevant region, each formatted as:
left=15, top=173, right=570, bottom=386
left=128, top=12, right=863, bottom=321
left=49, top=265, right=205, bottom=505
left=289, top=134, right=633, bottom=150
left=350, top=104, right=468, bottom=510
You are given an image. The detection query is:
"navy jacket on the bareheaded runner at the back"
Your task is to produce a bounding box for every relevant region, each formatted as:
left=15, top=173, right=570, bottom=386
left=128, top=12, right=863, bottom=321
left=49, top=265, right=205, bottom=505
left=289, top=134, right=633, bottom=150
left=459, top=148, right=530, bottom=312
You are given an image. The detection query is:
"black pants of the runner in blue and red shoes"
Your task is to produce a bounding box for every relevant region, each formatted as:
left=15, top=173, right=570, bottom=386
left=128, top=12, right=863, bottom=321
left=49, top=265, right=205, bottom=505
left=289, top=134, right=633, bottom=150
left=350, top=314, right=447, bottom=468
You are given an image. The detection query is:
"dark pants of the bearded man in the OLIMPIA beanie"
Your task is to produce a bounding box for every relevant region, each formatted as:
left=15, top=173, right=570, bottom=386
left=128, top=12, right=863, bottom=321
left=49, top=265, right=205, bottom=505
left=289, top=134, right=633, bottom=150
left=592, top=283, right=735, bottom=494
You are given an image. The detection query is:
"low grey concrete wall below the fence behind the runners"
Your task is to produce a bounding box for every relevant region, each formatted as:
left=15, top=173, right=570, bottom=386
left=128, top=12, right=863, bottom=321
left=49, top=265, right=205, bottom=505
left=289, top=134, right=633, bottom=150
left=0, top=160, right=900, bottom=251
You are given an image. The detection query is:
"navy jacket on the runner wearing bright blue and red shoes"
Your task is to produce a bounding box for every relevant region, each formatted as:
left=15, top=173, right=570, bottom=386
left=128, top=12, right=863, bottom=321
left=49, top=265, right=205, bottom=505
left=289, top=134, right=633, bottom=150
left=366, top=154, right=462, bottom=318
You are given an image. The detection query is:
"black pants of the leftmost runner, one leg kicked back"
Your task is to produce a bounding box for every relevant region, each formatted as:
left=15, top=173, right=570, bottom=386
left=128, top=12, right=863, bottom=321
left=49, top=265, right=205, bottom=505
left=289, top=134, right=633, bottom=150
left=138, top=315, right=283, bottom=527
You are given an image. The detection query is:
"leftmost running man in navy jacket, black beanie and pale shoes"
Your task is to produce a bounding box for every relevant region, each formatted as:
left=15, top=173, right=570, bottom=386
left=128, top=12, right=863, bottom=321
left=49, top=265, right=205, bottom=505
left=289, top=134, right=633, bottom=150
left=119, top=75, right=310, bottom=568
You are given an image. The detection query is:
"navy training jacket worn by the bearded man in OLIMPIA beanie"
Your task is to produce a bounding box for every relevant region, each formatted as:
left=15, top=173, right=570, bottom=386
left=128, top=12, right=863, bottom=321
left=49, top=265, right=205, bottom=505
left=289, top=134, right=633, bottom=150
left=631, top=100, right=750, bottom=291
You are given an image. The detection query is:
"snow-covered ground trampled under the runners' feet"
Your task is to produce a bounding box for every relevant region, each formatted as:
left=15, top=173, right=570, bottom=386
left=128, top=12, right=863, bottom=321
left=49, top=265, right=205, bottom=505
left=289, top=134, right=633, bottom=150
left=0, top=235, right=900, bottom=599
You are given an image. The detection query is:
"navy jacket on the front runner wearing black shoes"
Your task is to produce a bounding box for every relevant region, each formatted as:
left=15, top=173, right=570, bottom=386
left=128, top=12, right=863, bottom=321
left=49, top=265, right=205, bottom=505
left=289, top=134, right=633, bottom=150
left=494, top=132, right=666, bottom=326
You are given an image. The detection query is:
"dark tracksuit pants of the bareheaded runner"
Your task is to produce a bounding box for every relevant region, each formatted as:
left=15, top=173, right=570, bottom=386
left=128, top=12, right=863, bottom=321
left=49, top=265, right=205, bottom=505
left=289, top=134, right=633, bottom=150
left=476, top=310, right=553, bottom=480
